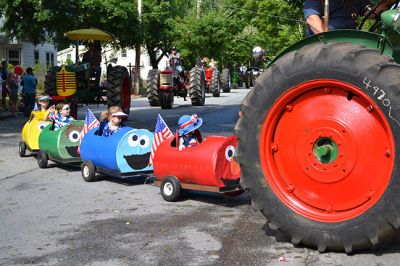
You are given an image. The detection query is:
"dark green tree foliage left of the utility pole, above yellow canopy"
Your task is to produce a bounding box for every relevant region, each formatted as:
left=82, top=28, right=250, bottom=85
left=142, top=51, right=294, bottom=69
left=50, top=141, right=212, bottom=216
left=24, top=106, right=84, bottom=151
left=0, top=0, right=140, bottom=48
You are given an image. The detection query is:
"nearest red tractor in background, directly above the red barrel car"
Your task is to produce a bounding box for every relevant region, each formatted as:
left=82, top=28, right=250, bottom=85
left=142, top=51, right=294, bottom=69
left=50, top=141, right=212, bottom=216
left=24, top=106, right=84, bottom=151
left=147, top=67, right=206, bottom=109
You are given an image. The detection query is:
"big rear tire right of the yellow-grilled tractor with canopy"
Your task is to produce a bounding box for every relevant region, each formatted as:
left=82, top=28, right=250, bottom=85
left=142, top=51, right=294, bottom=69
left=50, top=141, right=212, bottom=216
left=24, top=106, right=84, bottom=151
left=107, top=66, right=131, bottom=115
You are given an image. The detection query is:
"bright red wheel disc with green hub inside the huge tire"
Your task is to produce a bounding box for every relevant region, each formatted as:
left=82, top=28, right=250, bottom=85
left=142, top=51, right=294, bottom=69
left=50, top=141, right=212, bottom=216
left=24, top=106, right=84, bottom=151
left=260, top=80, right=395, bottom=222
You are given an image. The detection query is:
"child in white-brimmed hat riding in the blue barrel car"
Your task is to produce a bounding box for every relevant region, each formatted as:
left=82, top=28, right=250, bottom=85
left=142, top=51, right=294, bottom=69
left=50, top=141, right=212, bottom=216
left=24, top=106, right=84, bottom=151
left=97, top=106, right=128, bottom=137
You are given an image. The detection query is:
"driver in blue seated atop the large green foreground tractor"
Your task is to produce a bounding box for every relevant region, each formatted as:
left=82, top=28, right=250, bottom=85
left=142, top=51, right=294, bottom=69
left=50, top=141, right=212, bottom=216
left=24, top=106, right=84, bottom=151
left=304, top=0, right=396, bottom=36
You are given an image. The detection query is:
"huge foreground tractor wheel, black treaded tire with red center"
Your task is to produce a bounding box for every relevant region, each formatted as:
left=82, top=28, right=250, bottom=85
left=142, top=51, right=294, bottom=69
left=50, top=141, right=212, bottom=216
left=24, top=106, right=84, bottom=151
left=235, top=43, right=400, bottom=253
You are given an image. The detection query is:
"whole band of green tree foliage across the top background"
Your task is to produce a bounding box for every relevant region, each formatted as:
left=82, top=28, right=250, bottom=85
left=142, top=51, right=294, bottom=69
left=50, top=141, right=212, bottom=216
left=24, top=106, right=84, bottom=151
left=0, top=0, right=305, bottom=68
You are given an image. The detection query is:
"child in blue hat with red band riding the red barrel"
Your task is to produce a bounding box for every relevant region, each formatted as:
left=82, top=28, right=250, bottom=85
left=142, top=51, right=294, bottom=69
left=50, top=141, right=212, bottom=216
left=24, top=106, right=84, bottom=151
left=178, top=114, right=203, bottom=151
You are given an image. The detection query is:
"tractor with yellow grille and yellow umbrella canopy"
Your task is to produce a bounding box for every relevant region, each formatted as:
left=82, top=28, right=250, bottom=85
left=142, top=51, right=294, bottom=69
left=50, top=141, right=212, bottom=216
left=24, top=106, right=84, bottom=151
left=44, top=29, right=131, bottom=117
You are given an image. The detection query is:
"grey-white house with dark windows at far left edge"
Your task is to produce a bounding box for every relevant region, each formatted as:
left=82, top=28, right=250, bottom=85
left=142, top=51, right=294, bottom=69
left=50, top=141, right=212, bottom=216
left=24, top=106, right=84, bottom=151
left=0, top=18, right=57, bottom=67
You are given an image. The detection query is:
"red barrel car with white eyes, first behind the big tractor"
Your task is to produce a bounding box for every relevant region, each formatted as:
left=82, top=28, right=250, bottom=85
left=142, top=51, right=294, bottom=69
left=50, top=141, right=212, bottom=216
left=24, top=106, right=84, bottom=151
left=154, top=136, right=243, bottom=201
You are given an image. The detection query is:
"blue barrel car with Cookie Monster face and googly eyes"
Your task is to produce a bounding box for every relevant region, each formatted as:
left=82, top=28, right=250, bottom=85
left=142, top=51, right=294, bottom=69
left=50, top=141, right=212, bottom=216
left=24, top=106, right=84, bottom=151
left=80, top=127, right=153, bottom=182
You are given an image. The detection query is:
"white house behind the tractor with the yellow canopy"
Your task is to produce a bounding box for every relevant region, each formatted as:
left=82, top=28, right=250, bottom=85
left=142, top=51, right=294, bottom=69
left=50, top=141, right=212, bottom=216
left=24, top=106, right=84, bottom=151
left=57, top=45, right=168, bottom=80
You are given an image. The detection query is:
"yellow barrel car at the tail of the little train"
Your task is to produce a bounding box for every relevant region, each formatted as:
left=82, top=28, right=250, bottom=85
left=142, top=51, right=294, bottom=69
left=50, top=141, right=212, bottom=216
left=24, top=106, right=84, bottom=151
left=19, top=113, right=50, bottom=157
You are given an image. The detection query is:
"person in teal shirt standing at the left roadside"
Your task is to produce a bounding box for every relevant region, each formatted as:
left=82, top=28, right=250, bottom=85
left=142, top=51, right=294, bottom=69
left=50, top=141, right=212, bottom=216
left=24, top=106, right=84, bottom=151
left=21, top=67, right=37, bottom=117
